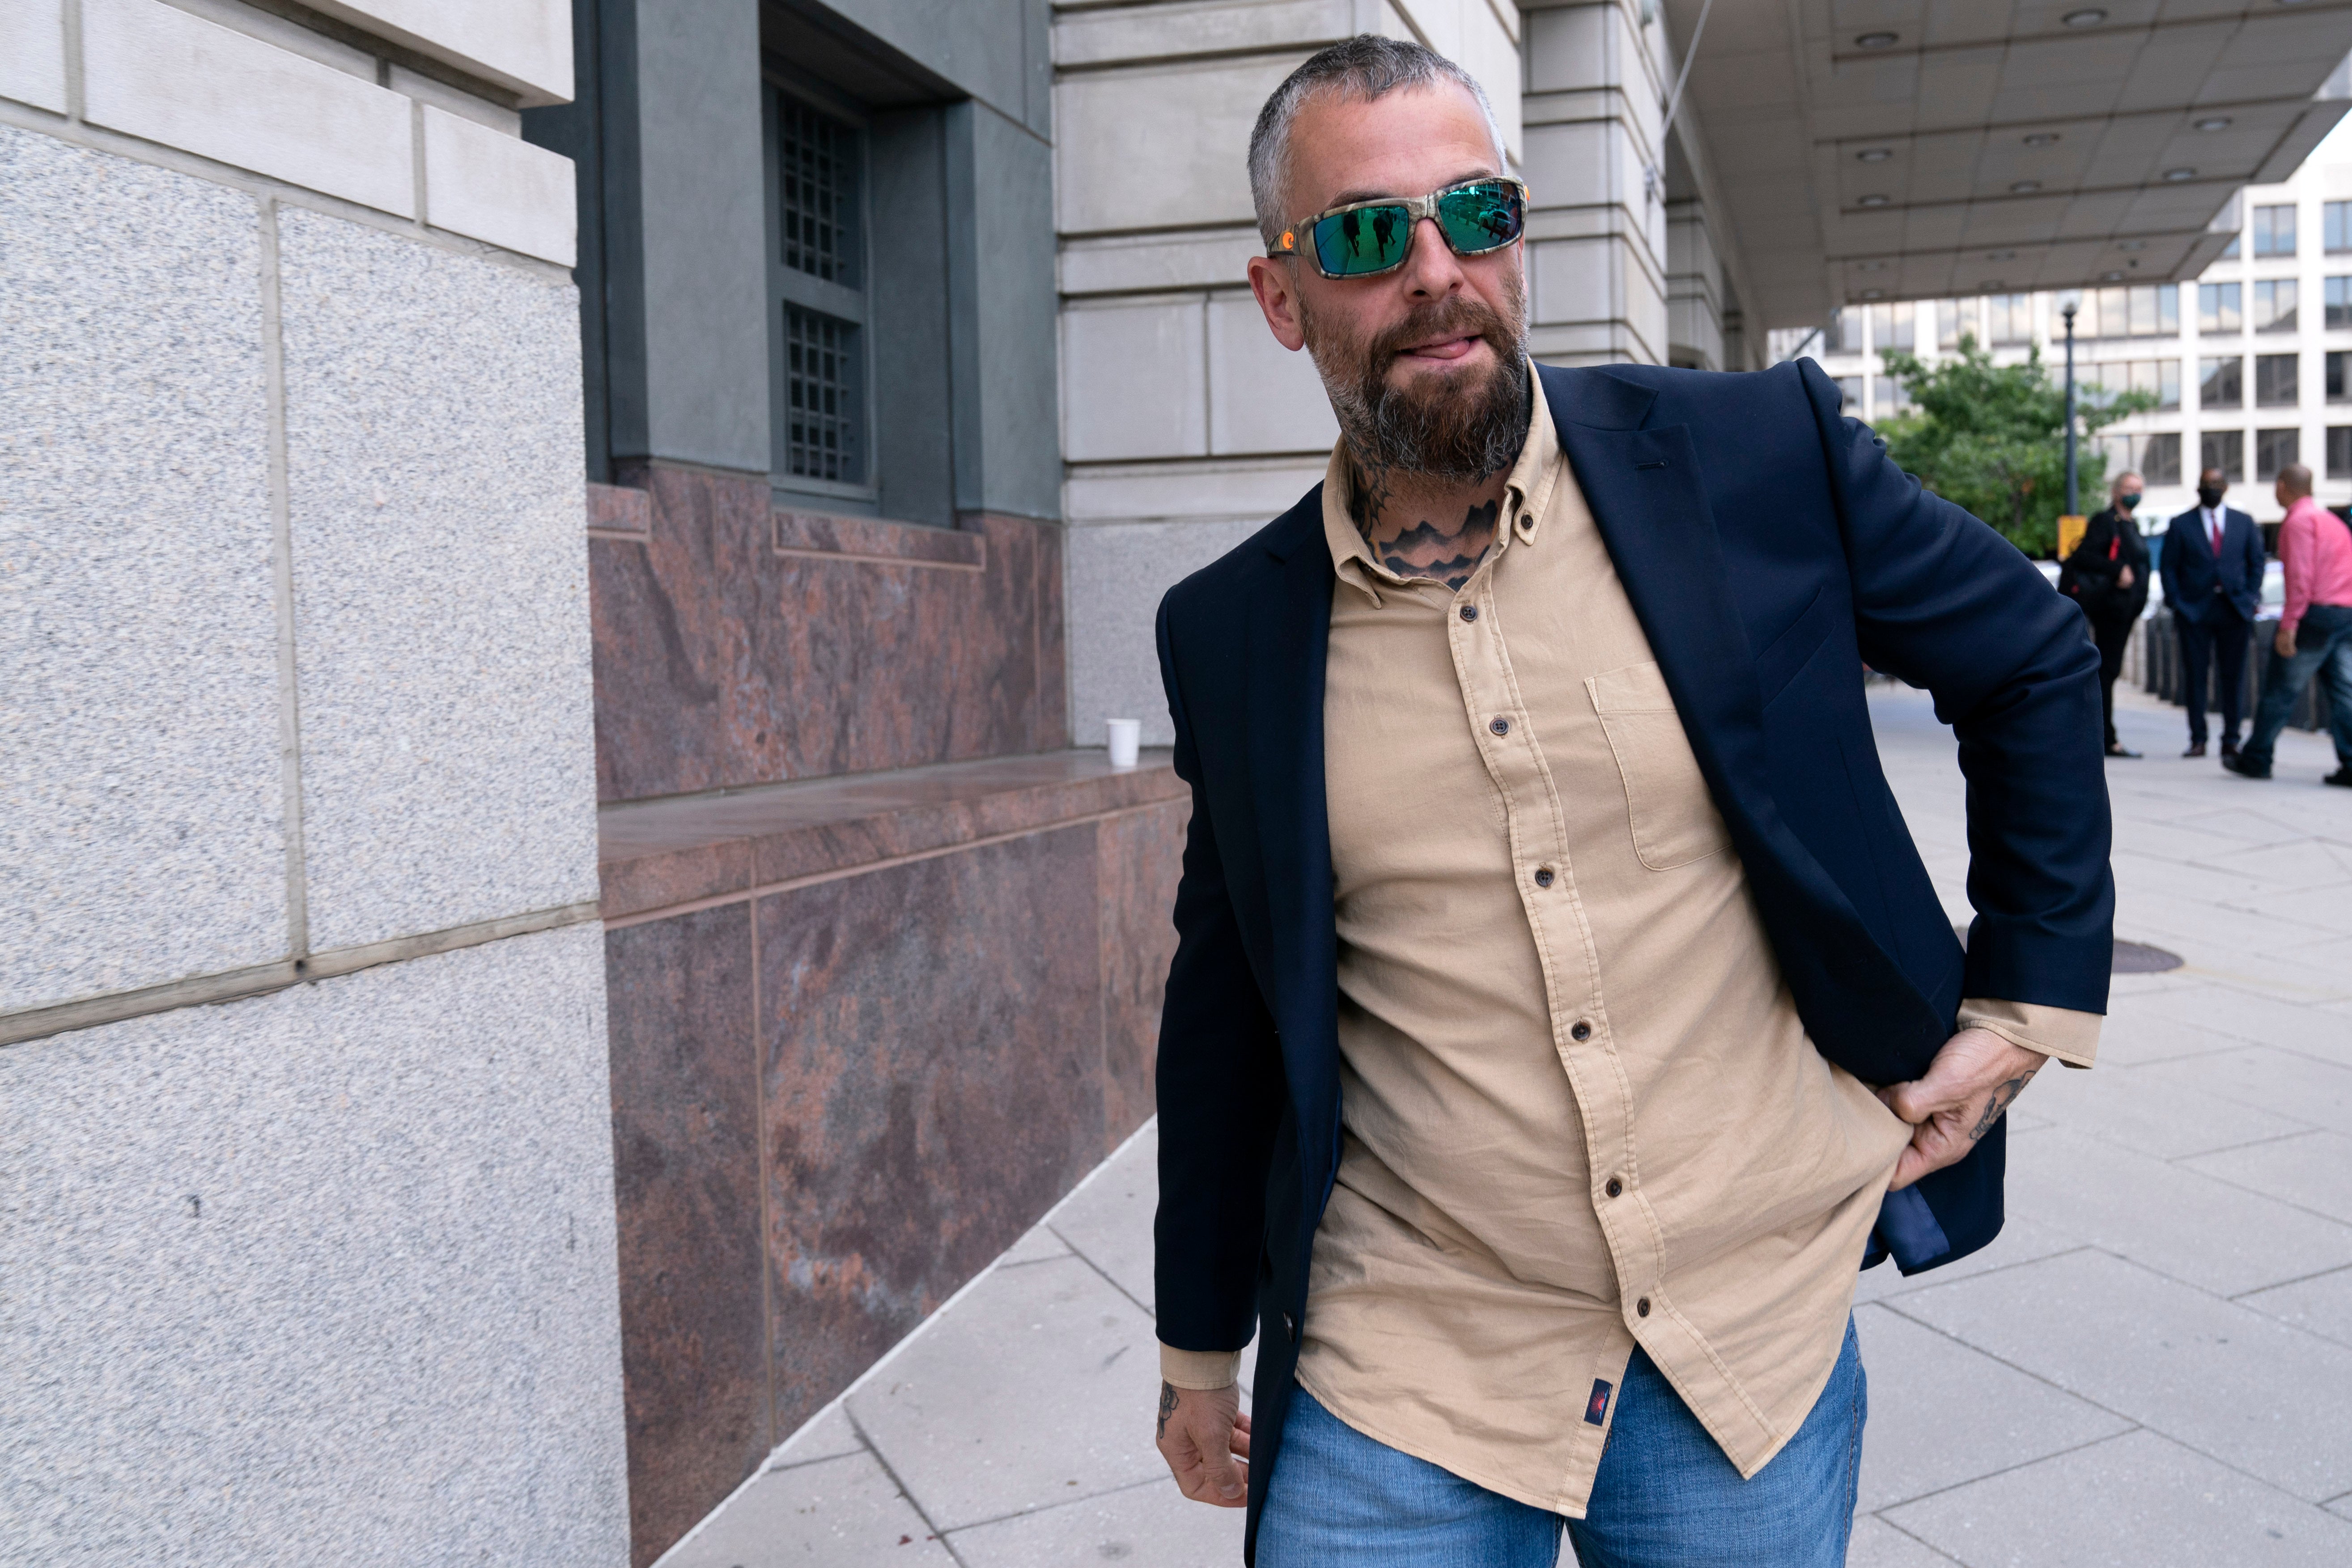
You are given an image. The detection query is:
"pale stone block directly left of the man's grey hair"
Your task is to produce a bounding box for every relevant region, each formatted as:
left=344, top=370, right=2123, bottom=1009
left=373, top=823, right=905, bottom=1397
left=1054, top=45, right=1315, bottom=235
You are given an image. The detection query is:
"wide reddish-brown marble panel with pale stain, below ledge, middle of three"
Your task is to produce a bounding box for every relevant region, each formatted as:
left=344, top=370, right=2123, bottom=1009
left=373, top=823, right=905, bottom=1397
left=757, top=823, right=1105, bottom=1432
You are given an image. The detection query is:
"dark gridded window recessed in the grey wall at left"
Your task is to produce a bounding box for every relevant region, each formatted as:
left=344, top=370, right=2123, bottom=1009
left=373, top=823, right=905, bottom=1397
left=769, top=87, right=868, bottom=489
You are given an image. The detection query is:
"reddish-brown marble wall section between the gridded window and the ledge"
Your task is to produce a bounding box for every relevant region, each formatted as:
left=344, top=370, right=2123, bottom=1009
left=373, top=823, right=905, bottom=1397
left=588, top=465, right=1063, bottom=802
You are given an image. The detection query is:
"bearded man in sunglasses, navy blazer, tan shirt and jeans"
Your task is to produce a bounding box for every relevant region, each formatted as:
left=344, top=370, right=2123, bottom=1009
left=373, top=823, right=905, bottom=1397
left=1138, top=27, right=2114, bottom=1568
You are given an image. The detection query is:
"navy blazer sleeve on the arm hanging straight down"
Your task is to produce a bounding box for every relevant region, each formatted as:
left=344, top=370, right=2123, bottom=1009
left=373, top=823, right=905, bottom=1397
left=1152, top=599, right=1286, bottom=1352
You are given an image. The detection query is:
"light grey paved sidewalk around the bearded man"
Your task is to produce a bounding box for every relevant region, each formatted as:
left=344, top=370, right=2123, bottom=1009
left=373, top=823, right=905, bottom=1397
left=663, top=691, right=2352, bottom=1568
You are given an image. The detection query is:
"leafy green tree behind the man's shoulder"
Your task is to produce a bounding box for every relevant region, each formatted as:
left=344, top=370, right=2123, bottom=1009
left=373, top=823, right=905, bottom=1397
left=1877, top=336, right=2157, bottom=557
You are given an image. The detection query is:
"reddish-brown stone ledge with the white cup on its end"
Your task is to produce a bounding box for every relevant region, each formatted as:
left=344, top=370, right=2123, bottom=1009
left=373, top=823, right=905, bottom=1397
left=598, top=750, right=1188, bottom=922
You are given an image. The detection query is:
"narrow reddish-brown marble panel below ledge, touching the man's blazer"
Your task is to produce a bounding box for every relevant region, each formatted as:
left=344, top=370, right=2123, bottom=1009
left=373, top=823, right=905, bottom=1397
left=1096, top=799, right=1193, bottom=1152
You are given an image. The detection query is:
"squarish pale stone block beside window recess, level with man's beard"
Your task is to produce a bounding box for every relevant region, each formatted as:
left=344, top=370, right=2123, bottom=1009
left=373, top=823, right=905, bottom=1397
left=1061, top=298, right=1209, bottom=463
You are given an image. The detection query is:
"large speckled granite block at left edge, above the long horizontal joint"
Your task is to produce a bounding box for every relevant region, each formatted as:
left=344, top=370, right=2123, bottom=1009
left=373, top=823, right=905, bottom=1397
left=0, top=127, right=287, bottom=1011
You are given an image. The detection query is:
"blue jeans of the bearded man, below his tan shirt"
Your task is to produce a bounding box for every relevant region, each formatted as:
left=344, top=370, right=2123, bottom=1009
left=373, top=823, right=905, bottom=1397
left=1258, top=1321, right=1870, bottom=1568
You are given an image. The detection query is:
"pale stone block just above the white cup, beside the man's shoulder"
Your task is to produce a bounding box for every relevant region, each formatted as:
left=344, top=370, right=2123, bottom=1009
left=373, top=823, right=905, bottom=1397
left=1068, top=519, right=1265, bottom=745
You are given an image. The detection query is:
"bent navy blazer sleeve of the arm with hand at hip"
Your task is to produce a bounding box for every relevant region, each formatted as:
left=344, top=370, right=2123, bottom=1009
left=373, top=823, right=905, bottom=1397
left=1804, top=362, right=2114, bottom=1013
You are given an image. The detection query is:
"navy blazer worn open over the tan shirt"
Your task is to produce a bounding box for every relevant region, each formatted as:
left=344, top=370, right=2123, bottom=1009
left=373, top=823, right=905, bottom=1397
left=1155, top=360, right=2114, bottom=1554
